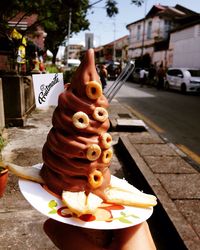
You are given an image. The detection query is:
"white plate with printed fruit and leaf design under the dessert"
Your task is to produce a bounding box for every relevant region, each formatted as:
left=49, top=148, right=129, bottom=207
left=19, top=172, right=153, bottom=229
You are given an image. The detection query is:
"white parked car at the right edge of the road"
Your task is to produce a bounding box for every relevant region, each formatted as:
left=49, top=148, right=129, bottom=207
left=165, top=68, right=200, bottom=93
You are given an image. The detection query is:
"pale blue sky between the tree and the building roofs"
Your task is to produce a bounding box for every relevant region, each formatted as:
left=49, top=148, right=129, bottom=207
left=56, top=0, right=200, bottom=57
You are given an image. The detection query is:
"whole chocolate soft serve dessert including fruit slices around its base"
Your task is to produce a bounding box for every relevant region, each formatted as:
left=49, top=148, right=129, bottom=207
left=6, top=49, right=157, bottom=215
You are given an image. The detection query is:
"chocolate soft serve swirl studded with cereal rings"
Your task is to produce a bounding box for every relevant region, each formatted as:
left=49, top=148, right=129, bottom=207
left=40, top=49, right=112, bottom=198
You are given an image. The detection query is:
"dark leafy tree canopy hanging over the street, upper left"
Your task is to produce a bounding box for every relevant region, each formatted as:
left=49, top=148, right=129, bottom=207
left=0, top=0, right=144, bottom=62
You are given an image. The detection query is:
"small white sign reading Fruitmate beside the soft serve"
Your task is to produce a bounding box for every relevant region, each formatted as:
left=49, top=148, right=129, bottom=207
left=32, top=73, right=64, bottom=108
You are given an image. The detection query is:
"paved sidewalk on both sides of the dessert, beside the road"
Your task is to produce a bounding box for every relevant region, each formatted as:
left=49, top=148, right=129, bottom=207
left=0, top=100, right=200, bottom=250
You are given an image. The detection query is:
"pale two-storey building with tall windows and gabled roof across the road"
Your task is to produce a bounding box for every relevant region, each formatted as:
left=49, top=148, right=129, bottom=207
left=126, top=4, right=197, bottom=67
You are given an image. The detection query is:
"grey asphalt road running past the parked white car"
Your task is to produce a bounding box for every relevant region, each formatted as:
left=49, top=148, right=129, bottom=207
left=108, top=82, right=200, bottom=164
